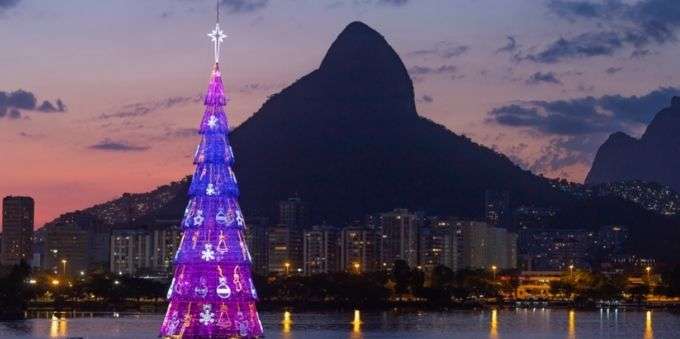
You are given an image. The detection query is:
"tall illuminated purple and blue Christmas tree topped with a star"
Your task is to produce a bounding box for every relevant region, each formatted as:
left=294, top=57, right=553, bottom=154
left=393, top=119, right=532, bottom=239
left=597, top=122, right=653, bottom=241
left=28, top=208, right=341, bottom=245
left=161, top=11, right=263, bottom=338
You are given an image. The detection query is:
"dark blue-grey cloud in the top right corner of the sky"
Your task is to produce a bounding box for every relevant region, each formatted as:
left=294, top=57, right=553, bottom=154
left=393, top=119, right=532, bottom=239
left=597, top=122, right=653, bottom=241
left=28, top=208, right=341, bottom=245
left=526, top=0, right=680, bottom=63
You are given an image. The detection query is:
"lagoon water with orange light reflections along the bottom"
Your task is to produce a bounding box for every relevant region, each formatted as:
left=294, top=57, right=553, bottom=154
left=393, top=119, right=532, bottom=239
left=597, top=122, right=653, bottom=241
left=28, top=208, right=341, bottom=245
left=0, top=309, right=680, bottom=339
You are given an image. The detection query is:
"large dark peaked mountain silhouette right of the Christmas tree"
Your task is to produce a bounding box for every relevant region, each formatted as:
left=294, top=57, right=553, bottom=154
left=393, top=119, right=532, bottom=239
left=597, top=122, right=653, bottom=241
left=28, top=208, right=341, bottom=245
left=230, top=22, right=564, bottom=222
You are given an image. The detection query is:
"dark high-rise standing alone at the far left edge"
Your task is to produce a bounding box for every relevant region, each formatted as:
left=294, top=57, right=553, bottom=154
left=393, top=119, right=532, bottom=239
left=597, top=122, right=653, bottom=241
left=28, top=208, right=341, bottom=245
left=0, top=196, right=35, bottom=265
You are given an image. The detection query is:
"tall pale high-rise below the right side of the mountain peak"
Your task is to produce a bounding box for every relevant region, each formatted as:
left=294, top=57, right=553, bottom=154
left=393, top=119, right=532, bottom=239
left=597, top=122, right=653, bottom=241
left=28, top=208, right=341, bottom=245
left=379, top=209, right=423, bottom=269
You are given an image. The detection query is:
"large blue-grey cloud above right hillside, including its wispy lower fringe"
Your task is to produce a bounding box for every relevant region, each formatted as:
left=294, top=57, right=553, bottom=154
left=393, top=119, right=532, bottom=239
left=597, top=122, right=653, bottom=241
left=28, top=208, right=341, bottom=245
left=487, top=87, right=680, bottom=173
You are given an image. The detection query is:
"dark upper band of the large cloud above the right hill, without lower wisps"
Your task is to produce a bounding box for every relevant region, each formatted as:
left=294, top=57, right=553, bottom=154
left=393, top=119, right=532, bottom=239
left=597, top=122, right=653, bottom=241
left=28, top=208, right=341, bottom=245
left=488, top=87, right=680, bottom=136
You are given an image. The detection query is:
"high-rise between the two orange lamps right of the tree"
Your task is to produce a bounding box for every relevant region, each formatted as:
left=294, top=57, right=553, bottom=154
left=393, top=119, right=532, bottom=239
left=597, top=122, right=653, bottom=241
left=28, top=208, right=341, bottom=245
left=302, top=225, right=339, bottom=275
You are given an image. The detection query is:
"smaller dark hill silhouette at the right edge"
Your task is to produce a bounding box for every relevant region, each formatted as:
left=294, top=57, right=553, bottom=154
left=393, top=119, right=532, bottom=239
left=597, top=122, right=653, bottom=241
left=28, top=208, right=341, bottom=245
left=585, top=97, right=680, bottom=191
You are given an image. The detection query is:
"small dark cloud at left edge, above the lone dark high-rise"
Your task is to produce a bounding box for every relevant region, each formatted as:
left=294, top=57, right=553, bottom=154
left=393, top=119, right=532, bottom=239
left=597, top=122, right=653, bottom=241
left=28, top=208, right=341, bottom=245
left=0, top=89, right=66, bottom=119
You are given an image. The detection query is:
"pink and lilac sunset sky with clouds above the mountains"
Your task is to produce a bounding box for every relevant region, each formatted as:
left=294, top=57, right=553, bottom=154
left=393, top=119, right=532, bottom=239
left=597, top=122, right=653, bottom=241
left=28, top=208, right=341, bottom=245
left=0, top=0, right=680, bottom=227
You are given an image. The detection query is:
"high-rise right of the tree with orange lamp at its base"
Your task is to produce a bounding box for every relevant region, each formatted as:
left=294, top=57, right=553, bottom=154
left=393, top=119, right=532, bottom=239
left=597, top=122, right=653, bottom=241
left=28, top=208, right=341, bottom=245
left=267, top=225, right=302, bottom=274
